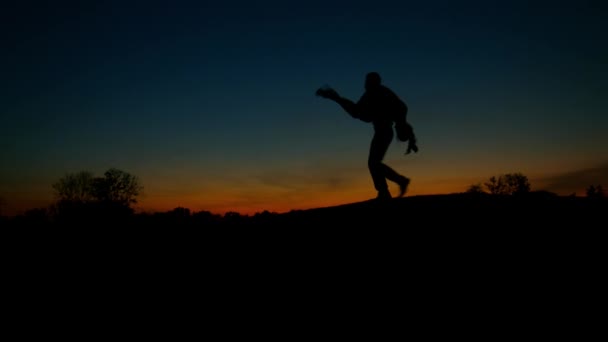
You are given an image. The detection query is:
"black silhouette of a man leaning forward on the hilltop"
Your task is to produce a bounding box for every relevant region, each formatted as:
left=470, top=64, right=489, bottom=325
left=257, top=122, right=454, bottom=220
left=316, top=72, right=410, bottom=200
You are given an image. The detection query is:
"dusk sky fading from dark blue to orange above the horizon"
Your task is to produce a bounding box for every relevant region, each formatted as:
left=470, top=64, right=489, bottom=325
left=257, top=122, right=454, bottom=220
left=0, top=0, right=608, bottom=215
